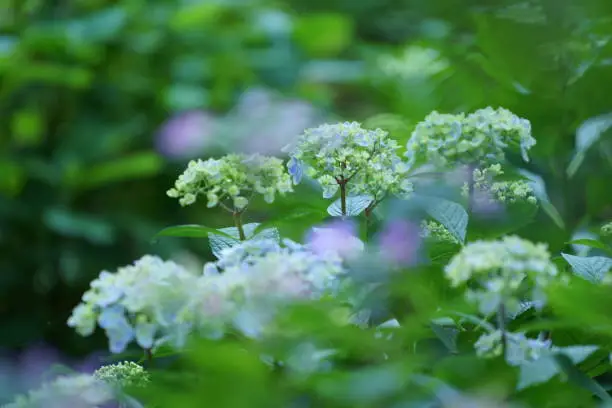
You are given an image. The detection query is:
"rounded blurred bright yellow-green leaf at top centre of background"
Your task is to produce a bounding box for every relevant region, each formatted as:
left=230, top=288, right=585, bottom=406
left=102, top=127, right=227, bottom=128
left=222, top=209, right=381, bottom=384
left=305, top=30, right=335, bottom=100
left=294, top=13, right=353, bottom=57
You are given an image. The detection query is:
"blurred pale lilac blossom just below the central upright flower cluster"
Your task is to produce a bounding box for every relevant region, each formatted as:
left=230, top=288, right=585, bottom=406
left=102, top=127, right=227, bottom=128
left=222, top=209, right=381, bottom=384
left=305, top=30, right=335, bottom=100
left=306, top=220, right=364, bottom=258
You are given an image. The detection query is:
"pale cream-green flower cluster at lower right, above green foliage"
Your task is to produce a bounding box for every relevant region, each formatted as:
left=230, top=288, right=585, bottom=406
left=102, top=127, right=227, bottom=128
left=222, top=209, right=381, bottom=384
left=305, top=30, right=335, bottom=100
left=444, top=236, right=558, bottom=315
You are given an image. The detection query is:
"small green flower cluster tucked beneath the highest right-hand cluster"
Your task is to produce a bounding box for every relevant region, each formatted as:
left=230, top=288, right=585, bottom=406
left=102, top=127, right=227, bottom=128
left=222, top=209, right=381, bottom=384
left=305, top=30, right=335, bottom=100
left=462, top=163, right=537, bottom=204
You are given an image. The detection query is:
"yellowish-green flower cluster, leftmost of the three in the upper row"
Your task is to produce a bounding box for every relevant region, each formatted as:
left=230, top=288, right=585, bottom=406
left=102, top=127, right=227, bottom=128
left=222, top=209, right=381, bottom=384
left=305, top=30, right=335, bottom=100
left=167, top=154, right=293, bottom=212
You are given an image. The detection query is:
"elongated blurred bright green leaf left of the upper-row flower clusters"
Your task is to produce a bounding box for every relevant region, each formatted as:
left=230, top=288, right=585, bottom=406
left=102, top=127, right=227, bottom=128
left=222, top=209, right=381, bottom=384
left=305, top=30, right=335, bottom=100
left=66, top=152, right=163, bottom=190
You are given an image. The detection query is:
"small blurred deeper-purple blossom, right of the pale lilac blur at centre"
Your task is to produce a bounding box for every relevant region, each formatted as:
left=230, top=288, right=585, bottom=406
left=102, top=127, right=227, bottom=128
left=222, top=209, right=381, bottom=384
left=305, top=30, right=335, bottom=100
left=378, top=220, right=421, bottom=266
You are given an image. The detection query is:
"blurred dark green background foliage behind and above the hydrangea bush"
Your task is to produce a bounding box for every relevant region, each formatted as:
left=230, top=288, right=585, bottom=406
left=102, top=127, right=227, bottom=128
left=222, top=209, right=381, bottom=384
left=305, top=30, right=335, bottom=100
left=0, top=0, right=612, bottom=372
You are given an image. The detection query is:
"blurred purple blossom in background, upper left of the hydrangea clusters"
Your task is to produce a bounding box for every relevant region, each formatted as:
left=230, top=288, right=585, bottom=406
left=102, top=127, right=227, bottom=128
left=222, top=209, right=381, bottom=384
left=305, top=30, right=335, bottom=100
left=156, top=110, right=217, bottom=159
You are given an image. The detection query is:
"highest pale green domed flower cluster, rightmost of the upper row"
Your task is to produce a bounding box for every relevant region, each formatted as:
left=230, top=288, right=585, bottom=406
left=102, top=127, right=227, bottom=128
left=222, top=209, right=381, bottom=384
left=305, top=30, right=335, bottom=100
left=406, top=107, right=536, bottom=168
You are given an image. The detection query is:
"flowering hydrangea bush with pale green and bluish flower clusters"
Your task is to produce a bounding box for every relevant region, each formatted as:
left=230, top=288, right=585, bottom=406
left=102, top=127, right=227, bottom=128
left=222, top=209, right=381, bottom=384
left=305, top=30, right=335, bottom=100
left=11, top=108, right=612, bottom=407
